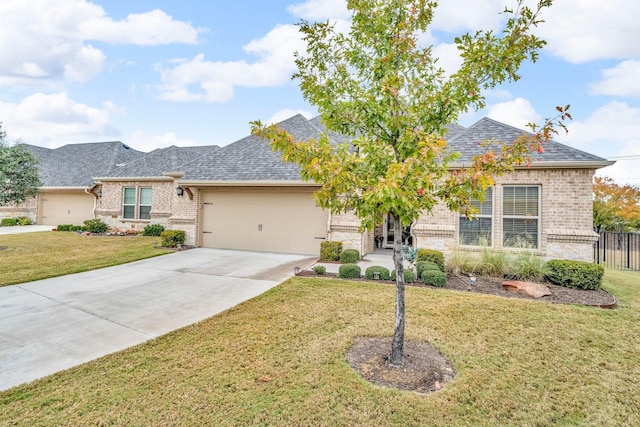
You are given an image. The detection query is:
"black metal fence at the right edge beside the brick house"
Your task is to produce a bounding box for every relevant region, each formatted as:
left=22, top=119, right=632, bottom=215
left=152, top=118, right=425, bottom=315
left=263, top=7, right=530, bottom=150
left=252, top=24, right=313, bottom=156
left=593, top=231, right=640, bottom=270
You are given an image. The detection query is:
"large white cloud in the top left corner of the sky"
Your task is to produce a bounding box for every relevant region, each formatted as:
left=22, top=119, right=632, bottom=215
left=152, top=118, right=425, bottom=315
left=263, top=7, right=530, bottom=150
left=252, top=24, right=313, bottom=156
left=0, top=0, right=200, bottom=87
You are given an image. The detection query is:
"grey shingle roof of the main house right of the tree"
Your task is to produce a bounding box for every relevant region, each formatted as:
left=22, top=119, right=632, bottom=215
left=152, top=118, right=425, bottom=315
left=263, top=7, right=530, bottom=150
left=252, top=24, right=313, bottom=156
left=447, top=117, right=607, bottom=167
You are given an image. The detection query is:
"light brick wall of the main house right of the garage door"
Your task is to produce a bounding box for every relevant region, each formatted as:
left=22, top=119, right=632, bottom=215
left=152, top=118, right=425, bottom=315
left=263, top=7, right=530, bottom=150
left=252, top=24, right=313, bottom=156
left=330, top=169, right=597, bottom=261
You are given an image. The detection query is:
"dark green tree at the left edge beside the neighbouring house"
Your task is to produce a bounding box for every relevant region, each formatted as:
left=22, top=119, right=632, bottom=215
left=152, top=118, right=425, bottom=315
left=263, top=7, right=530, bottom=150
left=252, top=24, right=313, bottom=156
left=0, top=123, right=42, bottom=206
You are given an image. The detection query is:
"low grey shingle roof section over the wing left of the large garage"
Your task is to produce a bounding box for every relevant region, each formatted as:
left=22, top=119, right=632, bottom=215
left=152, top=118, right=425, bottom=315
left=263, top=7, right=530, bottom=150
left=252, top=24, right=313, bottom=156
left=108, top=145, right=220, bottom=177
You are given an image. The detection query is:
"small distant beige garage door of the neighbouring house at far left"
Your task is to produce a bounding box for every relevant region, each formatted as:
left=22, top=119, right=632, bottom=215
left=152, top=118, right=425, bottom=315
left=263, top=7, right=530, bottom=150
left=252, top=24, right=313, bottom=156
left=38, top=193, right=94, bottom=226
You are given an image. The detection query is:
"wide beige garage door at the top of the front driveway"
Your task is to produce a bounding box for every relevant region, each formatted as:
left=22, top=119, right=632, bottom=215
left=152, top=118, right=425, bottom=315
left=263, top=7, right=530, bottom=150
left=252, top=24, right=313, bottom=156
left=201, top=189, right=327, bottom=255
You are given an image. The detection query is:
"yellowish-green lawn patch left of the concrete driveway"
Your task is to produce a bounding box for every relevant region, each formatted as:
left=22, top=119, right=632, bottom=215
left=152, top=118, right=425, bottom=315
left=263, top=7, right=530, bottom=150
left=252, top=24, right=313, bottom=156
left=0, top=231, right=170, bottom=286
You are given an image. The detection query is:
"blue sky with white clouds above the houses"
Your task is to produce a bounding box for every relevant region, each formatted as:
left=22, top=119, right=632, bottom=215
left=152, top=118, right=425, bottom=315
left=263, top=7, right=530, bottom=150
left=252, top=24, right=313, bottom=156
left=0, top=0, right=640, bottom=185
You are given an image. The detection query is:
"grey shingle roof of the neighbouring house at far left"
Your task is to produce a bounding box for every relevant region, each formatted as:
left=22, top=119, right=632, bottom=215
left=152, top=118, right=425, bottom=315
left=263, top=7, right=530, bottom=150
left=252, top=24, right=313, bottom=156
left=27, top=141, right=145, bottom=187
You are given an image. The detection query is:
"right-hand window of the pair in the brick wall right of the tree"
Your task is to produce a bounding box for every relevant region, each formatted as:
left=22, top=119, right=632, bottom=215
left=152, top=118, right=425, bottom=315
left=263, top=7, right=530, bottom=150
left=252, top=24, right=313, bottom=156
left=502, top=185, right=540, bottom=249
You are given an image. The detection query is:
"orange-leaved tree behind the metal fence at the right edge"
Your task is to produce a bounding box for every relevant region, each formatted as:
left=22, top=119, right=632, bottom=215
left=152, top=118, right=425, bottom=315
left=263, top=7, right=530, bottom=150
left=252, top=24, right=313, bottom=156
left=593, top=176, right=640, bottom=231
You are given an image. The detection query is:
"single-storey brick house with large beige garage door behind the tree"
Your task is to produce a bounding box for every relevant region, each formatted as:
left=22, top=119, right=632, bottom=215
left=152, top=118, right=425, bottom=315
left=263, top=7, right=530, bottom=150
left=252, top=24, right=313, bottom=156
left=7, top=115, right=612, bottom=260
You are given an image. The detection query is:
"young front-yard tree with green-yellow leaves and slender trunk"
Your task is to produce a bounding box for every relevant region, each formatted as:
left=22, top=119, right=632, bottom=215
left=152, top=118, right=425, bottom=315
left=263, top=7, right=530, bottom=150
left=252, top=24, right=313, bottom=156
left=253, top=0, right=566, bottom=365
